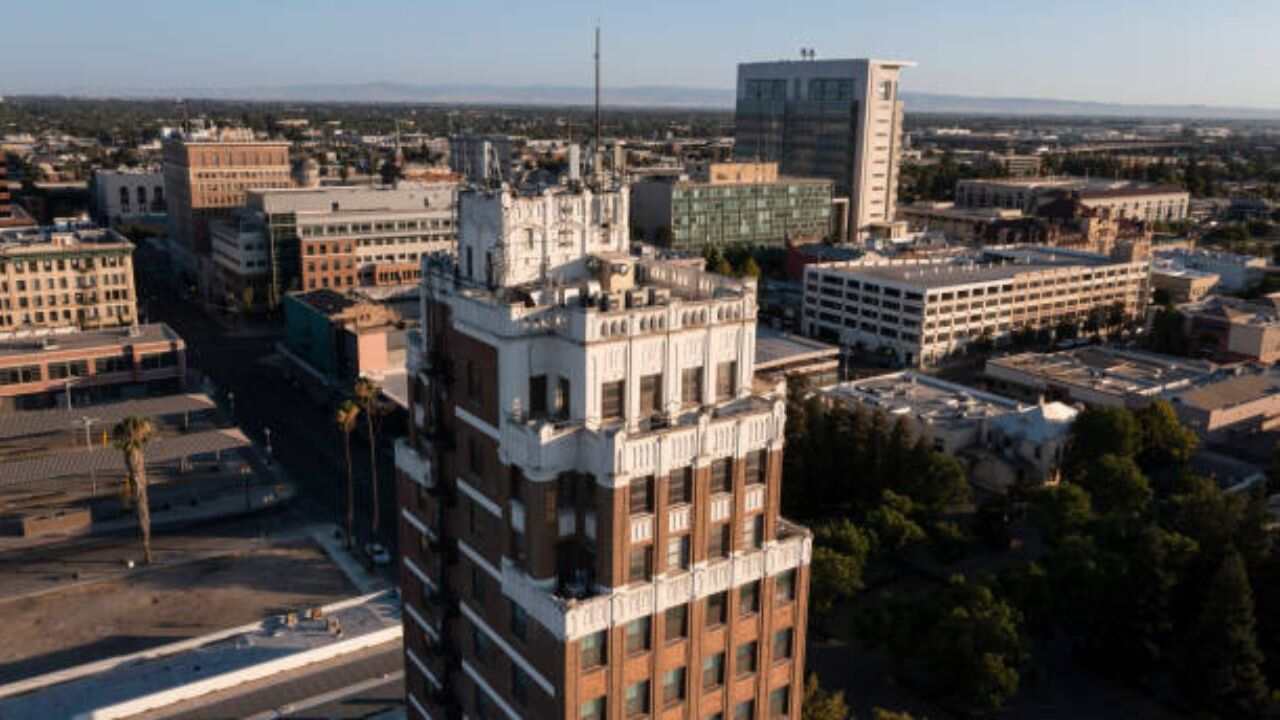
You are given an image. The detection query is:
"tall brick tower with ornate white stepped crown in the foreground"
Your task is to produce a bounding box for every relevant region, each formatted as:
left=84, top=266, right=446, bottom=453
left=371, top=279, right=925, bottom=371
left=396, top=183, right=812, bottom=720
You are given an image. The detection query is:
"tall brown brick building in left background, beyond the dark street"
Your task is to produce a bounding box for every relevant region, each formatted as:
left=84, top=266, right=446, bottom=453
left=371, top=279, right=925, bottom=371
left=164, top=129, right=293, bottom=255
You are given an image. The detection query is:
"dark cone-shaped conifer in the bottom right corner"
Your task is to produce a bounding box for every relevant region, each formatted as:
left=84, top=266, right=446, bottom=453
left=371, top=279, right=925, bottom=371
left=1183, top=551, right=1270, bottom=717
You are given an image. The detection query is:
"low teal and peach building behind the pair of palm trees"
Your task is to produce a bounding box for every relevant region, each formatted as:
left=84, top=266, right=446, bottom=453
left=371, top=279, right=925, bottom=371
left=284, top=290, right=406, bottom=387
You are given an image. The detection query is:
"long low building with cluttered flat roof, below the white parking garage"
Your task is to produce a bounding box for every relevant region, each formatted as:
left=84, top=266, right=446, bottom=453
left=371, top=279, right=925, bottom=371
left=983, top=346, right=1219, bottom=410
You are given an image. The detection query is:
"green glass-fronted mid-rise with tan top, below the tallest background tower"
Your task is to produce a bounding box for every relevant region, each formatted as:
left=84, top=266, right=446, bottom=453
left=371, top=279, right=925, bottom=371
left=631, top=163, right=832, bottom=252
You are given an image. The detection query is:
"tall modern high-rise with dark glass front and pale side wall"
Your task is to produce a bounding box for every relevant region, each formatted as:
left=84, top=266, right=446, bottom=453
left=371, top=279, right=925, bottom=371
left=733, top=59, right=915, bottom=238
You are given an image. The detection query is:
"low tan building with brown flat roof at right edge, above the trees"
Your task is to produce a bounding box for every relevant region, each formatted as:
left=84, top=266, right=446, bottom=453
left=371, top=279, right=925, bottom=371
left=1172, top=365, right=1280, bottom=442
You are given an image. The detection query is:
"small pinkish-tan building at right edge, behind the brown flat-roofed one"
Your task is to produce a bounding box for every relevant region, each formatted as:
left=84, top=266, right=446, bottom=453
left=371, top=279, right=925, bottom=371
left=1178, top=295, right=1280, bottom=363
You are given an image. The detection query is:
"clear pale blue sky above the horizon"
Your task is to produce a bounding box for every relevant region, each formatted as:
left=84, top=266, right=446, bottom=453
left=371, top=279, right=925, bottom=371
left=0, top=0, right=1280, bottom=108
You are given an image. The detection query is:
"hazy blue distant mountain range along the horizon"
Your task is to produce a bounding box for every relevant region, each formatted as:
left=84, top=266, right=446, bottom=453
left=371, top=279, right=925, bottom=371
left=17, top=82, right=1280, bottom=120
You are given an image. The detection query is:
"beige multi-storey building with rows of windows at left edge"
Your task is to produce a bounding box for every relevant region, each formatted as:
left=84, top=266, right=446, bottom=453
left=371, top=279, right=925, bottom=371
left=0, top=221, right=137, bottom=333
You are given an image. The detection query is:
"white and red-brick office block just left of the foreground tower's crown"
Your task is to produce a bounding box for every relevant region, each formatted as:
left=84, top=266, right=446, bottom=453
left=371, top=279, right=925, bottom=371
left=215, top=183, right=457, bottom=307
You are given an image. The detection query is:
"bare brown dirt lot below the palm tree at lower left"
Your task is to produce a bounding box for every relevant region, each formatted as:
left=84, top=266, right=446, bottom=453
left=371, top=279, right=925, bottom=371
left=0, top=541, right=356, bottom=684
